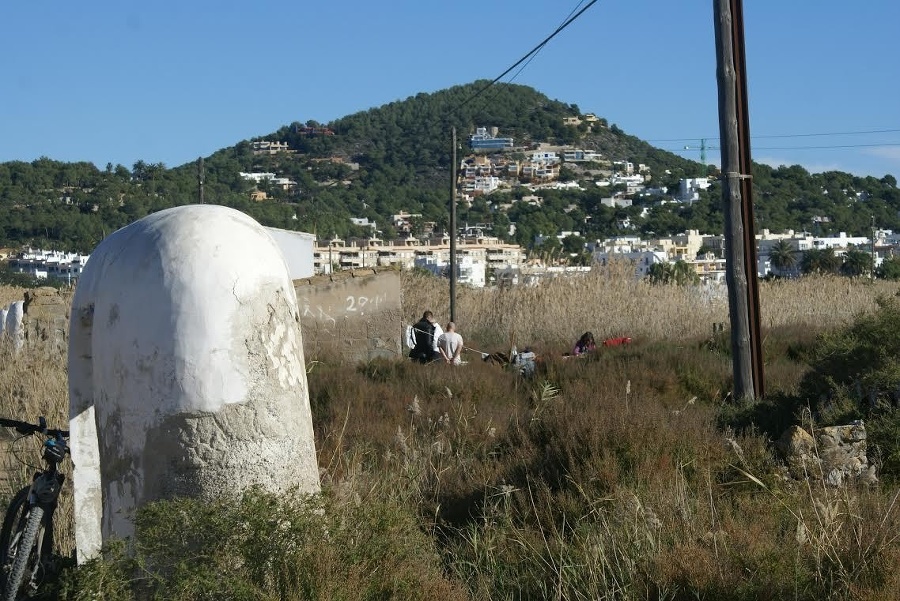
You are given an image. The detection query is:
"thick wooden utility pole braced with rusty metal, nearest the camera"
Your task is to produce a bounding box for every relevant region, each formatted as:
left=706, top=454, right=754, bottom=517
left=713, top=0, right=765, bottom=400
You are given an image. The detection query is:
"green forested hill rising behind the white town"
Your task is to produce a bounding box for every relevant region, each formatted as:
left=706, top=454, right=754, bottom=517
left=0, top=81, right=900, bottom=251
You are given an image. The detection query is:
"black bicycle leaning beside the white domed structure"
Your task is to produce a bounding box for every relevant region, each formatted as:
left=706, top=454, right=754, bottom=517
left=0, top=417, right=69, bottom=601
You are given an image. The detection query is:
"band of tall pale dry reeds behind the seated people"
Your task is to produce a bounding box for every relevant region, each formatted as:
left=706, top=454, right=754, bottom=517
left=403, top=263, right=898, bottom=345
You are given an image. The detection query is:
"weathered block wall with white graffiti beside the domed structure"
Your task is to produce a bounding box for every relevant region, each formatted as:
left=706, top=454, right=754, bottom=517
left=294, top=268, right=403, bottom=361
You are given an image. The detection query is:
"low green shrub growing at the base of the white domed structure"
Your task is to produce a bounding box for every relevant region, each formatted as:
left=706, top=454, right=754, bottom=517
left=61, top=491, right=463, bottom=601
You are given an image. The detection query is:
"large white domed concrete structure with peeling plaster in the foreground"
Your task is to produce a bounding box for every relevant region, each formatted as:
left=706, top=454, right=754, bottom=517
left=69, top=205, right=319, bottom=561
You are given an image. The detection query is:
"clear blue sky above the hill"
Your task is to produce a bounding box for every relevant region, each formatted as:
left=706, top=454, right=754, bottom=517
left=0, top=0, right=900, bottom=177
